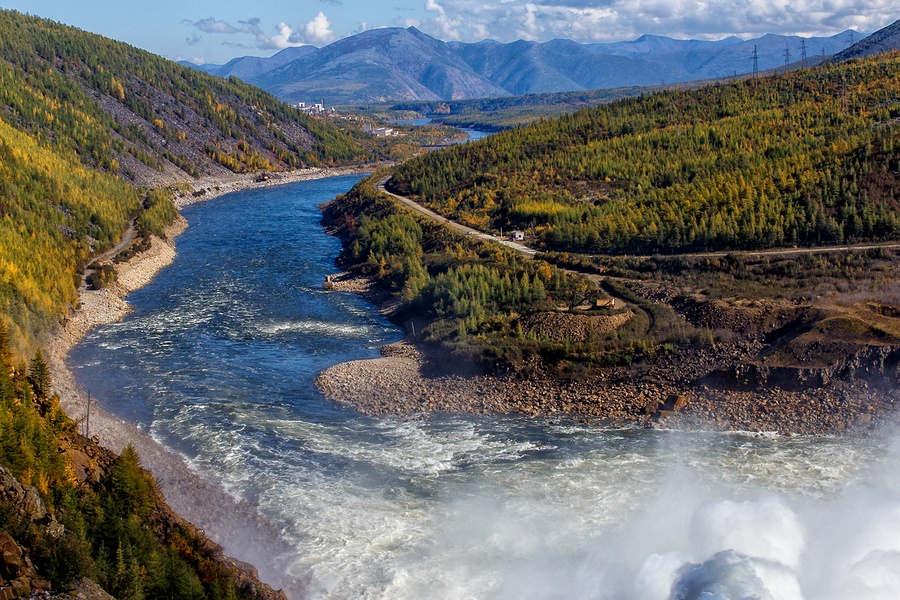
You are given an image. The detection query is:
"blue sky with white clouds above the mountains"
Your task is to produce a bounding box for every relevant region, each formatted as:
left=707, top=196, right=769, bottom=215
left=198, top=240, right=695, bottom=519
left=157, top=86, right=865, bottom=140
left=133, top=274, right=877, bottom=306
left=0, top=0, right=900, bottom=63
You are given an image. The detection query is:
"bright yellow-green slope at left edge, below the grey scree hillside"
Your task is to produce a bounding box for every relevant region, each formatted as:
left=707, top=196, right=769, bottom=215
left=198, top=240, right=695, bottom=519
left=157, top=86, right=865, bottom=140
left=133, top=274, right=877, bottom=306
left=0, top=121, right=141, bottom=349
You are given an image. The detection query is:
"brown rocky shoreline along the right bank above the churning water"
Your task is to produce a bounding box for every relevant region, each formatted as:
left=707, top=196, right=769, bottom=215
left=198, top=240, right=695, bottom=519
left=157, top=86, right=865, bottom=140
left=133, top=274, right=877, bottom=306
left=316, top=274, right=900, bottom=435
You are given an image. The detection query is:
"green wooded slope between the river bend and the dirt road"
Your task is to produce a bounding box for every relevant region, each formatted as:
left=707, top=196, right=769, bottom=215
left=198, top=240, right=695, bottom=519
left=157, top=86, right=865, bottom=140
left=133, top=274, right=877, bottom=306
left=323, top=173, right=597, bottom=368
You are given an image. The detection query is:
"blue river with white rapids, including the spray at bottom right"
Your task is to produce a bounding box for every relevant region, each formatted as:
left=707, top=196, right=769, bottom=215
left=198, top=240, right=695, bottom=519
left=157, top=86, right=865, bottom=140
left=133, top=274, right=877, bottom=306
left=69, top=176, right=900, bottom=600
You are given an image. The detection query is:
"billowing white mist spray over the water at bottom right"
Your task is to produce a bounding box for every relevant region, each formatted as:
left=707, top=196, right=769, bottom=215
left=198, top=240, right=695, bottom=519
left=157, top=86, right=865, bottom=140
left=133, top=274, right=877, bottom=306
left=428, top=426, right=900, bottom=600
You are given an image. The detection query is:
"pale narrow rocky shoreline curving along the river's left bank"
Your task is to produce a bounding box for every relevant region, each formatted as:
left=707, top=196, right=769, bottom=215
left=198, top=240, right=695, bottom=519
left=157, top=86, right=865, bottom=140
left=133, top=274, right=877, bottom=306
left=44, top=168, right=369, bottom=598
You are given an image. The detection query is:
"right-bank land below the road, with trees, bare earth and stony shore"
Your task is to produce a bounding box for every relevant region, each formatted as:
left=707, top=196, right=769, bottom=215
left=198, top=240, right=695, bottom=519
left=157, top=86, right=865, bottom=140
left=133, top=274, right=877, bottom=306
left=317, top=174, right=900, bottom=434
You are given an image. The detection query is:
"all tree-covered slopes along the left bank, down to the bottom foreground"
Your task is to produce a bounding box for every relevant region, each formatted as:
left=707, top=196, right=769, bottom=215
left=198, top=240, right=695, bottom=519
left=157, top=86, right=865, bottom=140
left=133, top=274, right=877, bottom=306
left=0, top=10, right=368, bottom=599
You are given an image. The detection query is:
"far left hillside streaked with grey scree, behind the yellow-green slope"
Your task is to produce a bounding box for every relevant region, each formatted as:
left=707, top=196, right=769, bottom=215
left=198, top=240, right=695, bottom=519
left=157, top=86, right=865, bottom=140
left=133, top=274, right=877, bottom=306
left=0, top=10, right=364, bottom=185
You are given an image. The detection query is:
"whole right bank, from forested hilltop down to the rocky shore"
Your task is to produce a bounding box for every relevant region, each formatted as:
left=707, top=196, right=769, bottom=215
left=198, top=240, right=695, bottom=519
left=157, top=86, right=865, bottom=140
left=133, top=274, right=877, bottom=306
left=320, top=53, right=900, bottom=426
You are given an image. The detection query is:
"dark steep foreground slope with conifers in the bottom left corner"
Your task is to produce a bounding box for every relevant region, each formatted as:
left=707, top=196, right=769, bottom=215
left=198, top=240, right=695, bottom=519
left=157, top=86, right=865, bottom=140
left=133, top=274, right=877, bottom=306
left=0, top=330, right=285, bottom=600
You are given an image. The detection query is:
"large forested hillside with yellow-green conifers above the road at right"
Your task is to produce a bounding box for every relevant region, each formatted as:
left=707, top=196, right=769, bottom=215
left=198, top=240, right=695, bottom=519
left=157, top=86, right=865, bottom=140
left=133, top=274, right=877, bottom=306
left=389, top=53, right=900, bottom=254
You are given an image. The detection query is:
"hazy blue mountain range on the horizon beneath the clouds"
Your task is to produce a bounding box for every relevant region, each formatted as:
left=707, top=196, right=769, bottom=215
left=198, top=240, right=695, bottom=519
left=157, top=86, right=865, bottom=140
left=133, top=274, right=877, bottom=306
left=182, top=27, right=863, bottom=105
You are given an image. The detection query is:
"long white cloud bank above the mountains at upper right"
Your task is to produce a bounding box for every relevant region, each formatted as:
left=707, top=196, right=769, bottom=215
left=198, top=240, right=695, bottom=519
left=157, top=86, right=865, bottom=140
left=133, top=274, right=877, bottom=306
left=404, top=0, right=896, bottom=42
